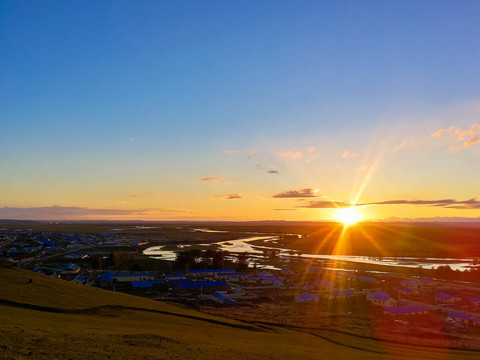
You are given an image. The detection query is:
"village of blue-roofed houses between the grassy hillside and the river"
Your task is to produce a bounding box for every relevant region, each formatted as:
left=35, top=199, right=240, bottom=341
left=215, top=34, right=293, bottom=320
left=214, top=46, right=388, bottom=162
left=0, top=229, right=480, bottom=350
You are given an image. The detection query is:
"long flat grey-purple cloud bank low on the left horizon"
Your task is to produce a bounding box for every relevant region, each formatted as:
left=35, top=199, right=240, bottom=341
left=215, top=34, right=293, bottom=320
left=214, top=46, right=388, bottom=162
left=0, top=205, right=189, bottom=220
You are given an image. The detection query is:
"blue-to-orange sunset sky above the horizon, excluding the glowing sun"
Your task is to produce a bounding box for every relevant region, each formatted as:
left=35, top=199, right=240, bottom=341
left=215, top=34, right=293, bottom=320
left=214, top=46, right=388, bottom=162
left=0, top=0, right=480, bottom=221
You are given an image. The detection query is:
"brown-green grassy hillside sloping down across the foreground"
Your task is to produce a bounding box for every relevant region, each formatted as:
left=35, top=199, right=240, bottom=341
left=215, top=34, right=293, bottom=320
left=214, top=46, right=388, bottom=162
left=0, top=268, right=479, bottom=360
